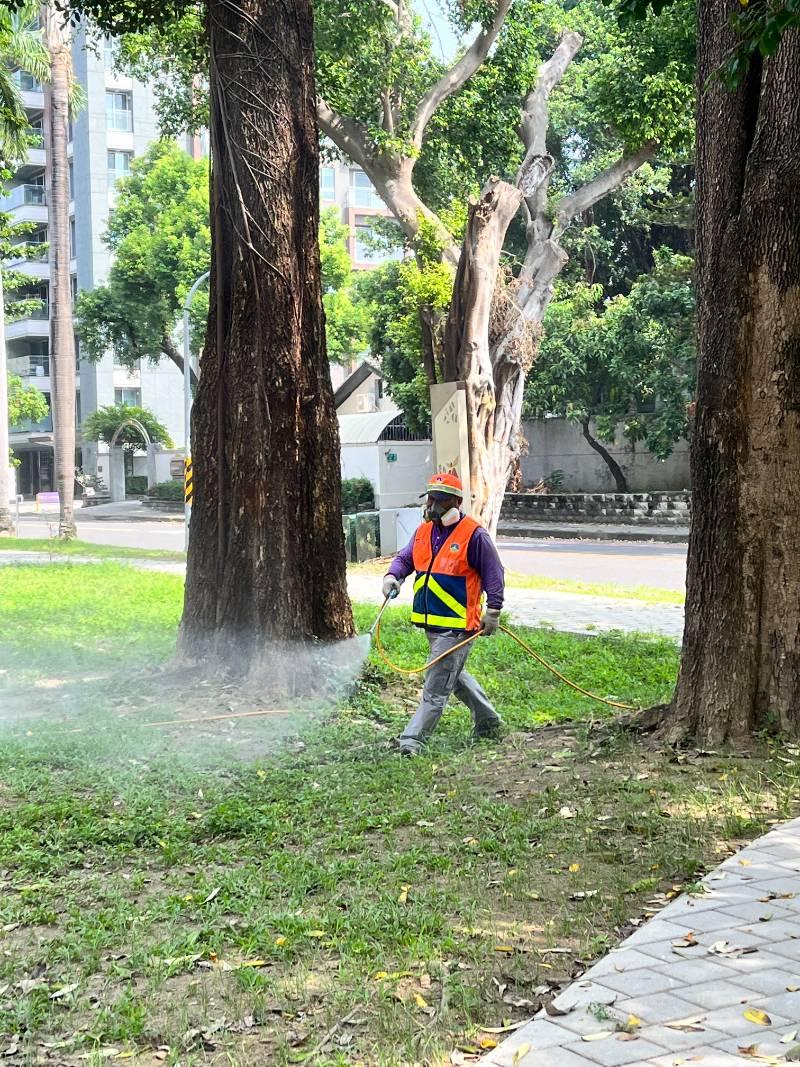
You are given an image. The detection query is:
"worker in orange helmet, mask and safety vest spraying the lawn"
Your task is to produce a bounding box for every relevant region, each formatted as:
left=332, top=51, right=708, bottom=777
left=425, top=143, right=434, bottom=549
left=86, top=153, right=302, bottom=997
left=383, top=474, right=505, bottom=757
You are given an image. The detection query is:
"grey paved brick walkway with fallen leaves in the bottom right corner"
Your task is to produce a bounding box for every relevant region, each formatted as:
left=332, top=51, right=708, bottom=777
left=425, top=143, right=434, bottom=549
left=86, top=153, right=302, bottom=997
left=481, top=819, right=800, bottom=1067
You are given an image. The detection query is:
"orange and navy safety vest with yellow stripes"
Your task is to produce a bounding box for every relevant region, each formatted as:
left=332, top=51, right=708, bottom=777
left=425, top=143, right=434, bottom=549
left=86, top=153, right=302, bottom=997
left=411, top=515, right=483, bottom=631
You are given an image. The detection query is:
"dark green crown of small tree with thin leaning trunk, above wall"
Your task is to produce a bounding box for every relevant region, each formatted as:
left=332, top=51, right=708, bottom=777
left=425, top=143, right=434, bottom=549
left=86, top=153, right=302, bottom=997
left=526, top=249, right=695, bottom=459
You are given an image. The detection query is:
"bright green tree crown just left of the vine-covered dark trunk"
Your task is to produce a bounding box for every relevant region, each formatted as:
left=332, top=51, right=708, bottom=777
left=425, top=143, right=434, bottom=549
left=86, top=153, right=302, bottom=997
left=76, top=141, right=211, bottom=367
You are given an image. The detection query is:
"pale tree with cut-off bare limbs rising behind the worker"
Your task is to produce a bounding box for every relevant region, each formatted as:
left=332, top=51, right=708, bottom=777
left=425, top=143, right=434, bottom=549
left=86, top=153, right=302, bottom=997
left=311, top=0, right=691, bottom=530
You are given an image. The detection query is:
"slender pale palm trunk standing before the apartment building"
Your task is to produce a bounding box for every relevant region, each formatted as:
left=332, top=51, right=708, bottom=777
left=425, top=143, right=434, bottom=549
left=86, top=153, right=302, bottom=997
left=43, top=4, right=76, bottom=538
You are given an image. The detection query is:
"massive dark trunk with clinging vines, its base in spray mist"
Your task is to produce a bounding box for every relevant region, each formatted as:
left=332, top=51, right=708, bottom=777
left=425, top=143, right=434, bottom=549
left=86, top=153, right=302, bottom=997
left=179, top=0, right=353, bottom=670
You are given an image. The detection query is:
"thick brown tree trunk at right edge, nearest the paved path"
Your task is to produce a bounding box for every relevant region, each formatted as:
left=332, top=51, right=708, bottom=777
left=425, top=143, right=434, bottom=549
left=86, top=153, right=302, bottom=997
left=671, top=10, right=800, bottom=744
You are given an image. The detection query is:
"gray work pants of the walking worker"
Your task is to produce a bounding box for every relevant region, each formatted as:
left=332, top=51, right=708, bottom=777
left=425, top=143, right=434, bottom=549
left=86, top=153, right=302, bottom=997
left=400, top=630, right=501, bottom=752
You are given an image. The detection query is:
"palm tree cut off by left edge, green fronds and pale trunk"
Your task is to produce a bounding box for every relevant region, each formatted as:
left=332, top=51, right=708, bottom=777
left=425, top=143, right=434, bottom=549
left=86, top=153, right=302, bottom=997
left=0, top=3, right=49, bottom=534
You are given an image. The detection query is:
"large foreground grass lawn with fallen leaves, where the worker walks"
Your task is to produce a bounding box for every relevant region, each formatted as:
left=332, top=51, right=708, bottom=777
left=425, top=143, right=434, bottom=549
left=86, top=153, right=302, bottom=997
left=0, top=562, right=798, bottom=1067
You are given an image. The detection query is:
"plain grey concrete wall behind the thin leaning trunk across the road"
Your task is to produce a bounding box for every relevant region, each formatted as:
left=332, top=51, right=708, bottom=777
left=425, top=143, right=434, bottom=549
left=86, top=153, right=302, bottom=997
left=522, top=418, right=690, bottom=493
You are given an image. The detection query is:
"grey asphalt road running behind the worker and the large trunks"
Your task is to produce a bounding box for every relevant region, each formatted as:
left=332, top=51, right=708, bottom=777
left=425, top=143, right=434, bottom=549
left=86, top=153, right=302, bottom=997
left=14, top=511, right=686, bottom=589
